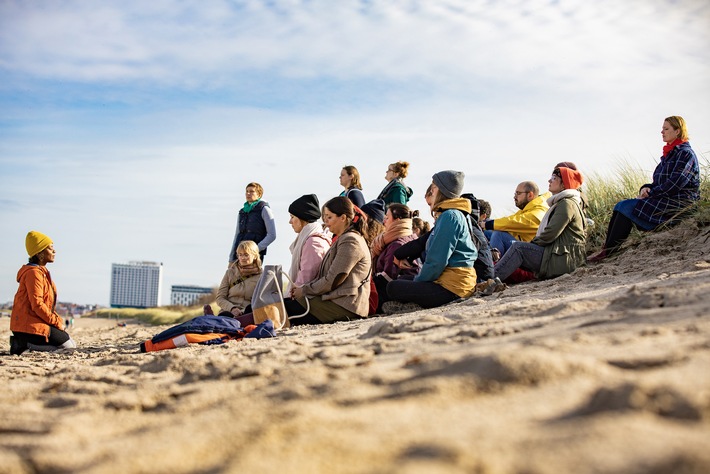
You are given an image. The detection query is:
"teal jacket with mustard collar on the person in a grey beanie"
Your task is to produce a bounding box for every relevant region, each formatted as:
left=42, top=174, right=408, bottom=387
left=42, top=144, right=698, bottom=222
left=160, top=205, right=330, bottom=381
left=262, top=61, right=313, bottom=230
left=414, top=198, right=478, bottom=281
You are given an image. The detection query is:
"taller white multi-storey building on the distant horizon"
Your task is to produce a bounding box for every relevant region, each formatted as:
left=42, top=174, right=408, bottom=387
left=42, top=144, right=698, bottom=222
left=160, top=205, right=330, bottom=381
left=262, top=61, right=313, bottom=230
left=111, top=262, right=163, bottom=308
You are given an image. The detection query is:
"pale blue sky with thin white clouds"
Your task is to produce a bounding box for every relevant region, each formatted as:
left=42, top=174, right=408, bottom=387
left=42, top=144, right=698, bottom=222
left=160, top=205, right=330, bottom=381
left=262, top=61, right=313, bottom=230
left=0, top=0, right=710, bottom=305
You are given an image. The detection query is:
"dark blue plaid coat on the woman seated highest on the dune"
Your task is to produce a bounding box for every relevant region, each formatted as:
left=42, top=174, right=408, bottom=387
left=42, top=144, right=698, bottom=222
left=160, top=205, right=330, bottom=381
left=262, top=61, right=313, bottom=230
left=633, top=142, right=700, bottom=225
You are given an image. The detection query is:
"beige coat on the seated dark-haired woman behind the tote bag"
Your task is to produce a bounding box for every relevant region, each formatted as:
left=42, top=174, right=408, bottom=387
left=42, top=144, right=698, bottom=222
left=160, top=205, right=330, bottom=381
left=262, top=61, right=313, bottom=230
left=303, top=232, right=372, bottom=318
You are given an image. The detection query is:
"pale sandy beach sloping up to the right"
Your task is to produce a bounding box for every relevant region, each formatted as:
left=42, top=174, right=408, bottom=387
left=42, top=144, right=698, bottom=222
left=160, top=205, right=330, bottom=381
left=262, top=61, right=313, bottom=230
left=0, top=223, right=710, bottom=474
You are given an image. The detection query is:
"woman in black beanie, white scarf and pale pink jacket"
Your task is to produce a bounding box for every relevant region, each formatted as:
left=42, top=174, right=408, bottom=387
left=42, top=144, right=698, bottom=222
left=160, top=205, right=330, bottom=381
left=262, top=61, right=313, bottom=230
left=288, top=194, right=331, bottom=286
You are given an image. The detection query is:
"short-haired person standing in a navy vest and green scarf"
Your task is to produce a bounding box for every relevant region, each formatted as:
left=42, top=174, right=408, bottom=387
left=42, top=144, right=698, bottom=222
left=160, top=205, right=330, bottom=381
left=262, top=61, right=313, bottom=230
left=229, top=183, right=276, bottom=263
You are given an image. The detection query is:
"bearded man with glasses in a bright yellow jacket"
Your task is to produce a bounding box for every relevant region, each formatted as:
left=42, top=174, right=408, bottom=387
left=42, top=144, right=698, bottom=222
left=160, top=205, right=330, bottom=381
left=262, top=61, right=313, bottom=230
left=484, top=181, right=549, bottom=255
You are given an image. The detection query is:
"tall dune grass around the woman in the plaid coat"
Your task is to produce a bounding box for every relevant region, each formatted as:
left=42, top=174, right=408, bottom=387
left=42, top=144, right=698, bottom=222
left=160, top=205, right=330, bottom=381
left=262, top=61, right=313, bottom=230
left=584, top=152, right=710, bottom=252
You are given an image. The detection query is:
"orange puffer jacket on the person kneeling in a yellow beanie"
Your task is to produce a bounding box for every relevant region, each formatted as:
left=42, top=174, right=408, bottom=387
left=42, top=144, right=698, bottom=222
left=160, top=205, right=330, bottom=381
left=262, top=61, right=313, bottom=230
left=10, top=264, right=64, bottom=340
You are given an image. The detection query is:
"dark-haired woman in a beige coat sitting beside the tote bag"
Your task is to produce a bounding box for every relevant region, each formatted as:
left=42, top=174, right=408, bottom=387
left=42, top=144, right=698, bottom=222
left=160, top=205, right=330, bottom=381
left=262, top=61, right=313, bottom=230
left=232, top=196, right=372, bottom=326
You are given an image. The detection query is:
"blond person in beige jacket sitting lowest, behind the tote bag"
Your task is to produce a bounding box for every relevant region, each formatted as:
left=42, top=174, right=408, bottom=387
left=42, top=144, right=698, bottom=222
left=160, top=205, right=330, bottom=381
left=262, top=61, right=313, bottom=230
left=213, top=240, right=261, bottom=317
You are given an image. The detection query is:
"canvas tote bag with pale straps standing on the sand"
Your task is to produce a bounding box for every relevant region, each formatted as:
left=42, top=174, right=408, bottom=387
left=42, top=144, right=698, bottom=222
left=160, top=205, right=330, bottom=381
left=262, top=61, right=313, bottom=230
left=251, top=265, right=310, bottom=329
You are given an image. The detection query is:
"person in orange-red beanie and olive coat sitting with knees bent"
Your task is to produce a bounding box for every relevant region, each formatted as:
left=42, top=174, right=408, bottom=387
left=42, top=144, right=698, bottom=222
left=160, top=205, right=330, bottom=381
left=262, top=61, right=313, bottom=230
left=495, top=167, right=586, bottom=281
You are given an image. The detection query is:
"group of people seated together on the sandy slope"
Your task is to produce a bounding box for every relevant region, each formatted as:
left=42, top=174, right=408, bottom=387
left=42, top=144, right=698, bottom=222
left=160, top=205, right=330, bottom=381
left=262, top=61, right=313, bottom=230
left=209, top=117, right=699, bottom=330
